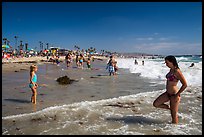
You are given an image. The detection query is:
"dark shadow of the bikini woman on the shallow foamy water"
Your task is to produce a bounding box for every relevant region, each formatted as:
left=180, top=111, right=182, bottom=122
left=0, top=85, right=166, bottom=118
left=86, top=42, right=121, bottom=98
left=106, top=116, right=164, bottom=125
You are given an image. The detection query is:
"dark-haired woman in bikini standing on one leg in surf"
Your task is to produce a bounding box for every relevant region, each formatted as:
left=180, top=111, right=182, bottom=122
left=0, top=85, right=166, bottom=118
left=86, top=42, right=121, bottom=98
left=153, top=56, right=187, bottom=124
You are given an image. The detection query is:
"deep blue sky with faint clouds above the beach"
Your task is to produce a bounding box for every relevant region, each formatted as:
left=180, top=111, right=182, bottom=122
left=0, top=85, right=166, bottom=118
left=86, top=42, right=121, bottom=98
left=2, top=2, right=202, bottom=55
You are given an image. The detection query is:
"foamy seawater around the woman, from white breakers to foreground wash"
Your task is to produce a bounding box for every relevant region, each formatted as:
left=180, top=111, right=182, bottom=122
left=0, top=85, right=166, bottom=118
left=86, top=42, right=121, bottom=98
left=2, top=56, right=202, bottom=135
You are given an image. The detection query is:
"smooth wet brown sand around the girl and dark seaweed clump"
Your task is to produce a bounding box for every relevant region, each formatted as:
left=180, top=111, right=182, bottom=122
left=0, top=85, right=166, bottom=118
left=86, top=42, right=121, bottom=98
left=2, top=56, right=164, bottom=116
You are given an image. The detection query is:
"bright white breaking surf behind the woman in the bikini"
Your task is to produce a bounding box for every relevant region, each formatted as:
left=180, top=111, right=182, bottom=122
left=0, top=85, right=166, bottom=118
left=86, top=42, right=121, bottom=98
left=117, top=57, right=202, bottom=87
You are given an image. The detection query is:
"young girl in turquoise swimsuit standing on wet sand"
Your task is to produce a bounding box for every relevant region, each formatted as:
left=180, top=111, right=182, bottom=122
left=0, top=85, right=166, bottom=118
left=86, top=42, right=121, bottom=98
left=29, top=65, right=38, bottom=104
